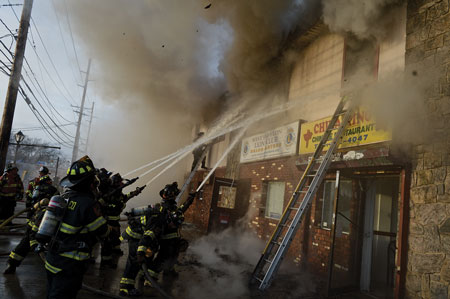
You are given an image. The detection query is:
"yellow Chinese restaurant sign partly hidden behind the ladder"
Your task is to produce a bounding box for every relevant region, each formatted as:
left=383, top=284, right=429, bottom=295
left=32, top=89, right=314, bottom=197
left=299, top=108, right=392, bottom=154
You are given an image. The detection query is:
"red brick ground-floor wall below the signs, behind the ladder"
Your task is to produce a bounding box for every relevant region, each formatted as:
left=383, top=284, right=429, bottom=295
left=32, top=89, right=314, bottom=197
left=240, top=157, right=356, bottom=278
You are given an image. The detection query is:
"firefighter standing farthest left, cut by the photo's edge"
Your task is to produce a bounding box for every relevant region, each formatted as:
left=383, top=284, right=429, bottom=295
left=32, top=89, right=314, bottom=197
left=0, top=163, right=23, bottom=225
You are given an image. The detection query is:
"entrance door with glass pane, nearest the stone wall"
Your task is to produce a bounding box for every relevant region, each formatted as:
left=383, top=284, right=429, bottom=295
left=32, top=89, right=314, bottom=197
left=360, top=177, right=399, bottom=298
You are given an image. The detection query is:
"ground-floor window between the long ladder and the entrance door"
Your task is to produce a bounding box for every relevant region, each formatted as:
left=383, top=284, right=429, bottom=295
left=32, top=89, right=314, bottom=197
left=316, top=180, right=353, bottom=233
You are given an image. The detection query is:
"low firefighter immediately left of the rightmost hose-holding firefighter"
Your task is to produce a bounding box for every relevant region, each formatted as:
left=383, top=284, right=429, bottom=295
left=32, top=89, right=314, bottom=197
left=119, top=204, right=163, bottom=296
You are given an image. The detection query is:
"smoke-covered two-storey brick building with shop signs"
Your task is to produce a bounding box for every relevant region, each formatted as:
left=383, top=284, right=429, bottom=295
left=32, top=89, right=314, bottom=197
left=186, top=0, right=450, bottom=298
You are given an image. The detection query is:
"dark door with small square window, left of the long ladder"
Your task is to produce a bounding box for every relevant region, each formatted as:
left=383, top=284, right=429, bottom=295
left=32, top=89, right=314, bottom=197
left=208, top=178, right=251, bottom=232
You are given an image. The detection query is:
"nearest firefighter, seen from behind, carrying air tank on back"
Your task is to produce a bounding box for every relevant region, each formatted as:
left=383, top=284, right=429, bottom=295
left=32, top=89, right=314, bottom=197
left=42, top=156, right=109, bottom=298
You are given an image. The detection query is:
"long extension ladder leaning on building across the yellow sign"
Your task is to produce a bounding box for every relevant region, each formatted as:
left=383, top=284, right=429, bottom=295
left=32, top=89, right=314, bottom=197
left=250, top=98, right=353, bottom=290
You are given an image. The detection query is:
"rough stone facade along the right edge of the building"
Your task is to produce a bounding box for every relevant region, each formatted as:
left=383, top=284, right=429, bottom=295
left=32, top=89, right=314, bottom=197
left=405, top=0, right=450, bottom=298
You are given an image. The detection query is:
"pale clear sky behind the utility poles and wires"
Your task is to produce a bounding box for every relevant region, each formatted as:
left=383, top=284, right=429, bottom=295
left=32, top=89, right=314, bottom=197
left=0, top=0, right=110, bottom=162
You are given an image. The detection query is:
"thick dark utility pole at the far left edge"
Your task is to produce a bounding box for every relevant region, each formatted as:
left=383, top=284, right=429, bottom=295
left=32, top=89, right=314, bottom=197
left=0, top=0, right=33, bottom=170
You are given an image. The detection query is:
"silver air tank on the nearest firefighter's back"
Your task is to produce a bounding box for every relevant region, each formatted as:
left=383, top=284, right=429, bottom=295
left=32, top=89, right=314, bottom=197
left=36, top=195, right=67, bottom=243
